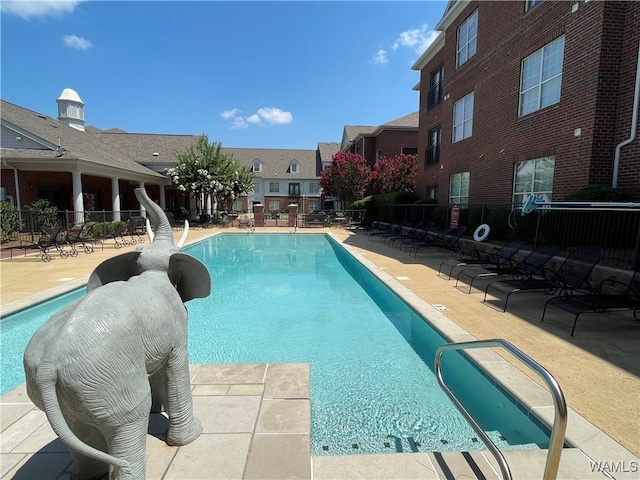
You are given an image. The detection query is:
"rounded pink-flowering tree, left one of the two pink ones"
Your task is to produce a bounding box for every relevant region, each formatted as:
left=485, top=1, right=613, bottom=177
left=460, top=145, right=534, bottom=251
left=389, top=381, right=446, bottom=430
left=320, top=152, right=371, bottom=208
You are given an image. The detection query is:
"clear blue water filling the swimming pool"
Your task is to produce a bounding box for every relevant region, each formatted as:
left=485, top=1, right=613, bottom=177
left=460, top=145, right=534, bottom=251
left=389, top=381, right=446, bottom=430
left=0, top=234, right=549, bottom=455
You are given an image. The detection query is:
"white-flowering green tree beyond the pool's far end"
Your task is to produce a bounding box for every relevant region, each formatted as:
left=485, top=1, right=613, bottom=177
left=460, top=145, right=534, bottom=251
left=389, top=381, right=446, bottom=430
left=166, top=134, right=253, bottom=217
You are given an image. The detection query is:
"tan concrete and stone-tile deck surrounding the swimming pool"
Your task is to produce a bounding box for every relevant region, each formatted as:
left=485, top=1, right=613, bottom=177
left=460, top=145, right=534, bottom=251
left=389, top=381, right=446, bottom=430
left=0, top=227, right=640, bottom=479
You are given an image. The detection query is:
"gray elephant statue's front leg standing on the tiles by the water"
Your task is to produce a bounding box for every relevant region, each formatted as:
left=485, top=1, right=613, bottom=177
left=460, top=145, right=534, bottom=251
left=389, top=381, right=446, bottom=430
left=167, top=344, right=202, bottom=446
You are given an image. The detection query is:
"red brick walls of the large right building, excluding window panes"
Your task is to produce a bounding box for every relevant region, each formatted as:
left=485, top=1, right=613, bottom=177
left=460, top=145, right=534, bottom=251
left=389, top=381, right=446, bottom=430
left=414, top=1, right=640, bottom=203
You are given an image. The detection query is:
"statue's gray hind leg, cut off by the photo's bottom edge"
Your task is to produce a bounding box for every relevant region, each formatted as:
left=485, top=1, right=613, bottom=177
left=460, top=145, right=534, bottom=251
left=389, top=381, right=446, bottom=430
left=107, top=418, right=150, bottom=480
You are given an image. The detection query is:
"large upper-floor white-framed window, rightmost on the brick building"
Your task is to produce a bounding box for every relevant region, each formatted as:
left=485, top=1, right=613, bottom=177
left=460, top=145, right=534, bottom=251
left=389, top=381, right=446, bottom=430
left=520, top=35, right=564, bottom=116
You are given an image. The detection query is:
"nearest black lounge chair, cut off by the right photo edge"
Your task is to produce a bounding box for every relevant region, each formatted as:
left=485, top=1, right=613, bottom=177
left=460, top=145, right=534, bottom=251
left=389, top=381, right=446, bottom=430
left=540, top=270, right=640, bottom=337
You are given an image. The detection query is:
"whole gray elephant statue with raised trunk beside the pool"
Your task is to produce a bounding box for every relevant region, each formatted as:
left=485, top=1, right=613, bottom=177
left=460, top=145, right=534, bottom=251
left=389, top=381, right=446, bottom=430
left=24, top=188, right=211, bottom=480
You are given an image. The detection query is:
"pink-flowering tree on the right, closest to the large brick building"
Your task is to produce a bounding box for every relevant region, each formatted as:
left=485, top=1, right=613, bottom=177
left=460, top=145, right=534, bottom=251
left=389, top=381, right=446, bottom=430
left=369, top=154, right=418, bottom=193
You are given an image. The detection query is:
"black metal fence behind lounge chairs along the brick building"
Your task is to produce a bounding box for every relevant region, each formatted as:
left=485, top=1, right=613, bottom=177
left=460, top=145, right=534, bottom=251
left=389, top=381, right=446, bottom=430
left=382, top=202, right=640, bottom=268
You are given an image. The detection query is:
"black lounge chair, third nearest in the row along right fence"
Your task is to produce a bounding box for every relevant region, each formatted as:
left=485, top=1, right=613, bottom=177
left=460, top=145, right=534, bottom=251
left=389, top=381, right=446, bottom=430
left=454, top=245, right=560, bottom=295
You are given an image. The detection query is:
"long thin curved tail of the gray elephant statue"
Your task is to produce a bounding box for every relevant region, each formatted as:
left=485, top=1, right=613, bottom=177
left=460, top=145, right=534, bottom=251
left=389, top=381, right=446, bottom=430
left=37, top=365, right=133, bottom=479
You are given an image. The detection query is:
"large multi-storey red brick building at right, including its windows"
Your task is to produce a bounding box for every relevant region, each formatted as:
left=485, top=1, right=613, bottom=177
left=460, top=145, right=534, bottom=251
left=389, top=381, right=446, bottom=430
left=412, top=0, right=640, bottom=204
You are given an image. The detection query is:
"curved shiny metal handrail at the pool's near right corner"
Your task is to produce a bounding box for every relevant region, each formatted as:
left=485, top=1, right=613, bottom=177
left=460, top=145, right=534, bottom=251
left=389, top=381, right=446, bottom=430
left=435, top=338, right=567, bottom=480
